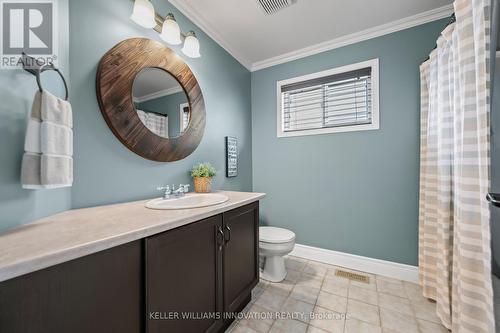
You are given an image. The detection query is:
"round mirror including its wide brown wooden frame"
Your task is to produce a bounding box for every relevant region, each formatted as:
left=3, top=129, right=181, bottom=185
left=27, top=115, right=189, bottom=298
left=96, top=38, right=206, bottom=162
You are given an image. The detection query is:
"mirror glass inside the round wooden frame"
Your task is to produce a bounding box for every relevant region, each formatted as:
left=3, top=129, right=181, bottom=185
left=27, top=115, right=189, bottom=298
left=132, top=67, right=191, bottom=138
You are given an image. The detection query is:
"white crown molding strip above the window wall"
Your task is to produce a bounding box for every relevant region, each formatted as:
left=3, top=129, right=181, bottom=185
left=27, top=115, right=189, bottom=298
left=254, top=5, right=453, bottom=72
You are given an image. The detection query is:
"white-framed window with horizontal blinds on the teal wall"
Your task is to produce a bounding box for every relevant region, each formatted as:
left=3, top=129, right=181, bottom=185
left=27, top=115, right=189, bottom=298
left=277, top=59, right=379, bottom=137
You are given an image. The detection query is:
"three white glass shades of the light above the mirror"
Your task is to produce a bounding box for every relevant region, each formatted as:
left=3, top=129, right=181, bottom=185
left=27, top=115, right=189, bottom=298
left=130, top=0, right=201, bottom=58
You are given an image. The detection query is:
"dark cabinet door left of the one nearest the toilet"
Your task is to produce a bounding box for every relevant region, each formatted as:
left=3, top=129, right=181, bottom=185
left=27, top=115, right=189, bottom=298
left=146, top=215, right=223, bottom=333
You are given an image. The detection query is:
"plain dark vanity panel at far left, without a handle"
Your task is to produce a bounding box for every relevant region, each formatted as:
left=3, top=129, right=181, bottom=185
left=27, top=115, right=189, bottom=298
left=0, top=241, right=144, bottom=333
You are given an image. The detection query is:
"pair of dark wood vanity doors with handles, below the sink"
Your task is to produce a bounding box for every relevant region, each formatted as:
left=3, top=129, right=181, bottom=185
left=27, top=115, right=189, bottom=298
left=146, top=203, right=259, bottom=333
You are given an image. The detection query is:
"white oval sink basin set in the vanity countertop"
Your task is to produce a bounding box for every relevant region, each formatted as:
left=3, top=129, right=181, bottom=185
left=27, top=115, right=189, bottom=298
left=146, top=193, right=229, bottom=209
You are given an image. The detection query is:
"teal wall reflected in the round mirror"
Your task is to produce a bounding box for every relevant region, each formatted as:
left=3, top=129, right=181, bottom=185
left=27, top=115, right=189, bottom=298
left=137, top=92, right=187, bottom=137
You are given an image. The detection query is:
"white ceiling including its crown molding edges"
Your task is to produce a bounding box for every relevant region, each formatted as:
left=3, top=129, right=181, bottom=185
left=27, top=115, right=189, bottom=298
left=169, top=0, right=453, bottom=70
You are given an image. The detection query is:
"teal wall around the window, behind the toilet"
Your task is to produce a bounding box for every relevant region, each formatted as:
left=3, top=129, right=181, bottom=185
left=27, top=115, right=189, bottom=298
left=252, top=20, right=447, bottom=265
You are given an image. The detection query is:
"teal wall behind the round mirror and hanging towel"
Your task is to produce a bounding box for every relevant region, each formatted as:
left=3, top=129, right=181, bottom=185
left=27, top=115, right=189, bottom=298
left=0, top=0, right=252, bottom=232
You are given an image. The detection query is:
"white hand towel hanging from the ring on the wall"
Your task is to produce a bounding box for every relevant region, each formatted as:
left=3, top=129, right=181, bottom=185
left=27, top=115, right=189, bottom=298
left=21, top=90, right=73, bottom=189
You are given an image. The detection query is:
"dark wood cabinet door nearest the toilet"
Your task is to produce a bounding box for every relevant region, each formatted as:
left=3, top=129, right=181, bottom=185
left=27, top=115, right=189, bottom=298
left=223, top=202, right=259, bottom=312
